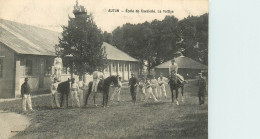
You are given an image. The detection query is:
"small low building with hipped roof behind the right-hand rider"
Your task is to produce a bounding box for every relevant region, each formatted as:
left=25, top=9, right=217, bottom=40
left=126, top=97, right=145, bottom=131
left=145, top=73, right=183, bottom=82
left=154, top=56, right=208, bottom=79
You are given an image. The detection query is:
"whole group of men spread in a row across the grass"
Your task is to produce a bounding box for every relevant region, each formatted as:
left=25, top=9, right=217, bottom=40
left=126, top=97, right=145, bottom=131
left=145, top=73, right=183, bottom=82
left=21, top=59, right=207, bottom=111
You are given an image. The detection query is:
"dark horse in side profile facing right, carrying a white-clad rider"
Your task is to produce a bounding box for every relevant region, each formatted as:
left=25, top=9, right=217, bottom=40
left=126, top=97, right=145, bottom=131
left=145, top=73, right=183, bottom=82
left=85, top=76, right=118, bottom=107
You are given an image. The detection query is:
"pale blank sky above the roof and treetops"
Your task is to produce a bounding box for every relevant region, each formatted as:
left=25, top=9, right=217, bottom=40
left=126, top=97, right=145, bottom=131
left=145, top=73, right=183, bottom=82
left=0, top=0, right=209, bottom=32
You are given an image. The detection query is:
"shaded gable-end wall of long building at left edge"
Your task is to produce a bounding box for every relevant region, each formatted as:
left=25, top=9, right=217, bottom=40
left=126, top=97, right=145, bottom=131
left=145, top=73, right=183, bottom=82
left=0, top=43, right=15, bottom=98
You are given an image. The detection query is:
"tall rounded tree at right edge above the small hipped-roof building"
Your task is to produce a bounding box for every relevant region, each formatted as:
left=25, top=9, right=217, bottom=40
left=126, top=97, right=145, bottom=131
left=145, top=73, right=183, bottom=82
left=177, top=14, right=208, bottom=65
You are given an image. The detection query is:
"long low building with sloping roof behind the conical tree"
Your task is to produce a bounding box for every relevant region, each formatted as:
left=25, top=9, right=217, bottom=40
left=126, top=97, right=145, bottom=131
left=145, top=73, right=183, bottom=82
left=0, top=19, right=139, bottom=98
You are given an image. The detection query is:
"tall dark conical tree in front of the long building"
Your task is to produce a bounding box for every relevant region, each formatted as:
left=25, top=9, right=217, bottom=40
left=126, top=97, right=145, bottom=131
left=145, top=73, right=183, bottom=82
left=57, top=3, right=106, bottom=75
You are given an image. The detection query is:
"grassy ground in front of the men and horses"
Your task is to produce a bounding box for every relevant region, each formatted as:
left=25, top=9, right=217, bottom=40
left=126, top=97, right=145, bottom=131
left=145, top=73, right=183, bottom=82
left=0, top=82, right=208, bottom=139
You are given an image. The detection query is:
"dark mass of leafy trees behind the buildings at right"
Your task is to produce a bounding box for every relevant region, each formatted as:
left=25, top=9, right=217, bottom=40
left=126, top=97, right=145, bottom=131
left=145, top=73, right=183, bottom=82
left=109, top=14, right=208, bottom=70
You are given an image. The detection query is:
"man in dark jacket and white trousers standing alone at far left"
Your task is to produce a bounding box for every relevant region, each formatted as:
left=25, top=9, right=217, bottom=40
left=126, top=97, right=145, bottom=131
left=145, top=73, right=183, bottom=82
left=21, top=78, right=33, bottom=111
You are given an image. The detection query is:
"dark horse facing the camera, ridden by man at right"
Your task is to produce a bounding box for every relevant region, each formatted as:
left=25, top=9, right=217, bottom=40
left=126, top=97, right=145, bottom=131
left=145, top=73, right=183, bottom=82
left=168, top=77, right=186, bottom=103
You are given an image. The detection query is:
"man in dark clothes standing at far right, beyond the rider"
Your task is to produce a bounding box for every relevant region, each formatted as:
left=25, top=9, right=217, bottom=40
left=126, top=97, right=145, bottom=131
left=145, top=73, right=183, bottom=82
left=198, top=73, right=206, bottom=105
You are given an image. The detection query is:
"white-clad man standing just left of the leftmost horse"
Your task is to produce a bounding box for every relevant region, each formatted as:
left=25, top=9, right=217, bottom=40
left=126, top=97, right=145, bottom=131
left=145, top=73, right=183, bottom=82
left=51, top=77, right=60, bottom=108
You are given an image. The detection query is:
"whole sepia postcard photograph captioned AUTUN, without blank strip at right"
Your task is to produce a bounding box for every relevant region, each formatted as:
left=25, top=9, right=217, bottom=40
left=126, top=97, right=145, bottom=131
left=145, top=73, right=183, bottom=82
left=0, top=0, right=209, bottom=139
